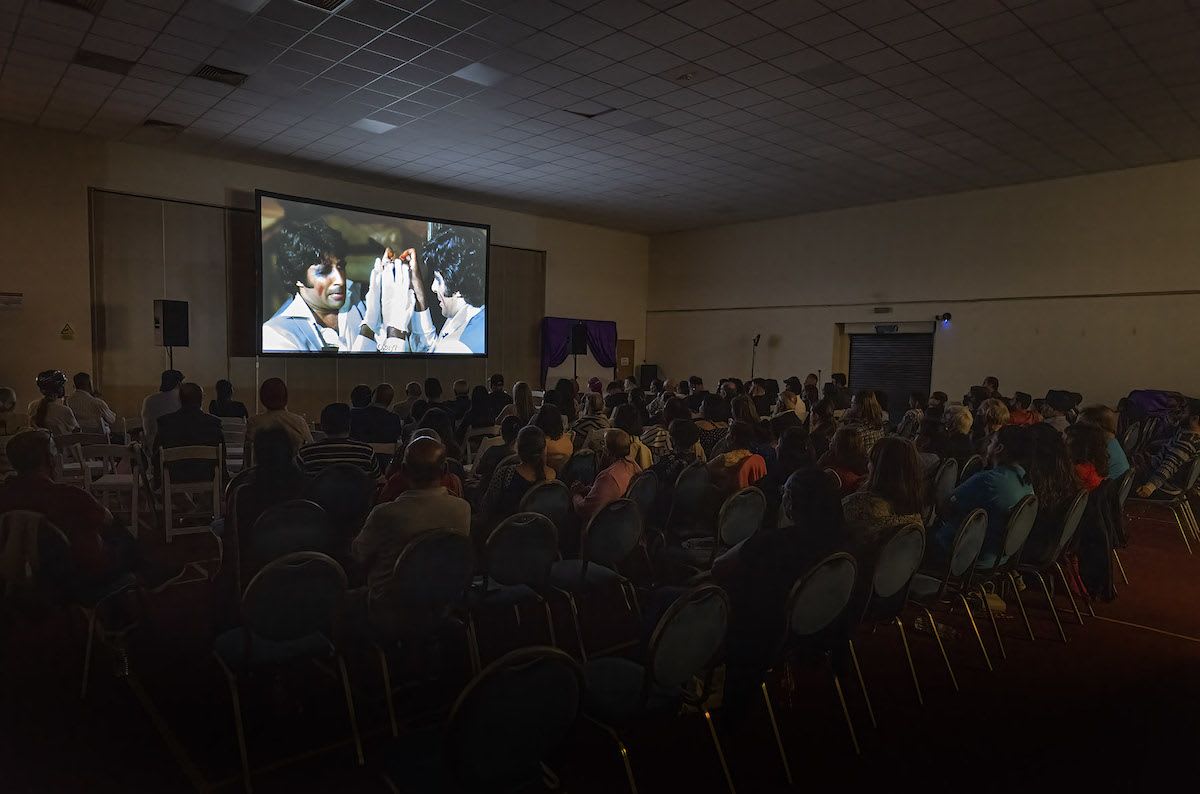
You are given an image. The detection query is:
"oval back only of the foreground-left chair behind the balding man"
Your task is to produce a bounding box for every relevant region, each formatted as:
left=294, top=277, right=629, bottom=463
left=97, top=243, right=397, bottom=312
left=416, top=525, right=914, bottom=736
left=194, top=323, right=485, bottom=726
left=241, top=552, right=346, bottom=643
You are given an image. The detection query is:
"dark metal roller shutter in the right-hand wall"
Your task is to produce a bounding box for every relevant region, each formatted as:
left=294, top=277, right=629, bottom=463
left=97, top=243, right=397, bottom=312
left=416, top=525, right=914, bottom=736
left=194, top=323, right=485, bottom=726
left=850, top=333, right=934, bottom=422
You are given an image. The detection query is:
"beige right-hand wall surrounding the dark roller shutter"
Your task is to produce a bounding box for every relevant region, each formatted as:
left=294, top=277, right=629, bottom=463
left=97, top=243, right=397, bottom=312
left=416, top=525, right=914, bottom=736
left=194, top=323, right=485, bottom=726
left=647, top=161, right=1200, bottom=410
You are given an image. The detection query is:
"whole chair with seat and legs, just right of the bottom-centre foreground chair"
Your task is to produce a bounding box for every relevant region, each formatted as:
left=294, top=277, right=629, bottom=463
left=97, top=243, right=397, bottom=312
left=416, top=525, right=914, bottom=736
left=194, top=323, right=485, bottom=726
left=583, top=584, right=733, bottom=794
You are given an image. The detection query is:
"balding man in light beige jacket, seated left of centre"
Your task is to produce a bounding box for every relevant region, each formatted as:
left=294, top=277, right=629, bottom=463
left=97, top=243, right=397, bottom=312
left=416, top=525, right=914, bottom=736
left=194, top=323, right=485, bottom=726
left=350, top=437, right=470, bottom=597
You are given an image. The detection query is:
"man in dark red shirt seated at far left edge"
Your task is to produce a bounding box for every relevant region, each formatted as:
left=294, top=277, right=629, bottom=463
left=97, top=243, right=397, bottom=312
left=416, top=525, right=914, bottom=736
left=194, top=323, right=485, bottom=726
left=0, top=429, right=182, bottom=588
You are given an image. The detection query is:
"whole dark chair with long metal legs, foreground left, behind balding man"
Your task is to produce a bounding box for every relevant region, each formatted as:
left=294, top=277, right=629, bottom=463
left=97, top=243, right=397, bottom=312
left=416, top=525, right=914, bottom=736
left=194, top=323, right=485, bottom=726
left=214, top=552, right=362, bottom=792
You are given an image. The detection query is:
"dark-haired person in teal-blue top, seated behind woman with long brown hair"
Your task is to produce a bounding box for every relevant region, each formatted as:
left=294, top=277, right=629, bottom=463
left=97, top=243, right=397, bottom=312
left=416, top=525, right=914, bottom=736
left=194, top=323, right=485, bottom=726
left=932, top=425, right=1033, bottom=559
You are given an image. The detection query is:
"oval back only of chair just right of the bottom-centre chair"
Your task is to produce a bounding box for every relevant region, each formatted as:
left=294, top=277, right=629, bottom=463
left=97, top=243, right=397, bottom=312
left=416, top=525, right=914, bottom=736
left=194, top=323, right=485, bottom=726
left=642, top=584, right=730, bottom=694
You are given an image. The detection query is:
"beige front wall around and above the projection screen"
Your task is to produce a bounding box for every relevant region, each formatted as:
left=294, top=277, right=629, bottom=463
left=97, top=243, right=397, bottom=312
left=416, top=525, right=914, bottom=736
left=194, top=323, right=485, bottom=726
left=0, top=125, right=648, bottom=412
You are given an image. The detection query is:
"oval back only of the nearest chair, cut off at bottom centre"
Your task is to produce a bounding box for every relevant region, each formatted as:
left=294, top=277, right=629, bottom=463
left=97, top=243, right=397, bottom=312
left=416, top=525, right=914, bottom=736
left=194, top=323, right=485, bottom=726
left=445, top=646, right=583, bottom=792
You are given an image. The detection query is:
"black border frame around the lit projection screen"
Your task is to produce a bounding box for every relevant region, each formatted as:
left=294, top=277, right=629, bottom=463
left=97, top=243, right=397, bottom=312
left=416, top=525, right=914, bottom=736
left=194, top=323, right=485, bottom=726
left=254, top=188, right=492, bottom=361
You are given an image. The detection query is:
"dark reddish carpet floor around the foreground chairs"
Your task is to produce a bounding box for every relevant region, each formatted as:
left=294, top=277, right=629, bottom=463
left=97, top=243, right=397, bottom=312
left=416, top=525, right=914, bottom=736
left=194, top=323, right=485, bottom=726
left=0, top=510, right=1200, bottom=793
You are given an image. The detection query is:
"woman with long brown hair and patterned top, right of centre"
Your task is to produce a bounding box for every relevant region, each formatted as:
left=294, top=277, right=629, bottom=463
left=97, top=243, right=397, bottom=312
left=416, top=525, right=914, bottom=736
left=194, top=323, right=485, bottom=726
left=841, top=435, right=925, bottom=558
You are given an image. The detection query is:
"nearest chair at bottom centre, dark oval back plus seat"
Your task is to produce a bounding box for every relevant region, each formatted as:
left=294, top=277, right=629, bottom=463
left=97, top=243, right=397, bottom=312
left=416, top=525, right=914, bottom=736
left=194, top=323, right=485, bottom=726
left=376, top=646, right=583, bottom=794
